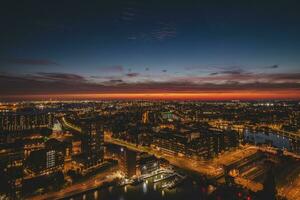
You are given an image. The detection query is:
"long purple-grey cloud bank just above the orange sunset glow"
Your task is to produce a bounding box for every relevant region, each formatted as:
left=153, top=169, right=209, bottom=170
left=0, top=72, right=300, bottom=97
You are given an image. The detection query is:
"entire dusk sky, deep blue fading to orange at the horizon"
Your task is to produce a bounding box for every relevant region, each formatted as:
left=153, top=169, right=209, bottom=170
left=0, top=0, right=300, bottom=100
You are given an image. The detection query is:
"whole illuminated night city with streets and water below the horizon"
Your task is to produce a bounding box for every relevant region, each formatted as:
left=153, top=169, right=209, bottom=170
left=0, top=100, right=300, bottom=200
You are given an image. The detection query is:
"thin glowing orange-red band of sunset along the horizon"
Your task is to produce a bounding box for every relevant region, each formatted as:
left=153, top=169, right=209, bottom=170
left=4, top=90, right=300, bottom=100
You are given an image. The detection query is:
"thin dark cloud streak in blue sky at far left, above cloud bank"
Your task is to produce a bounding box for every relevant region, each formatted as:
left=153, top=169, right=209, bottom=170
left=4, top=58, right=59, bottom=66
